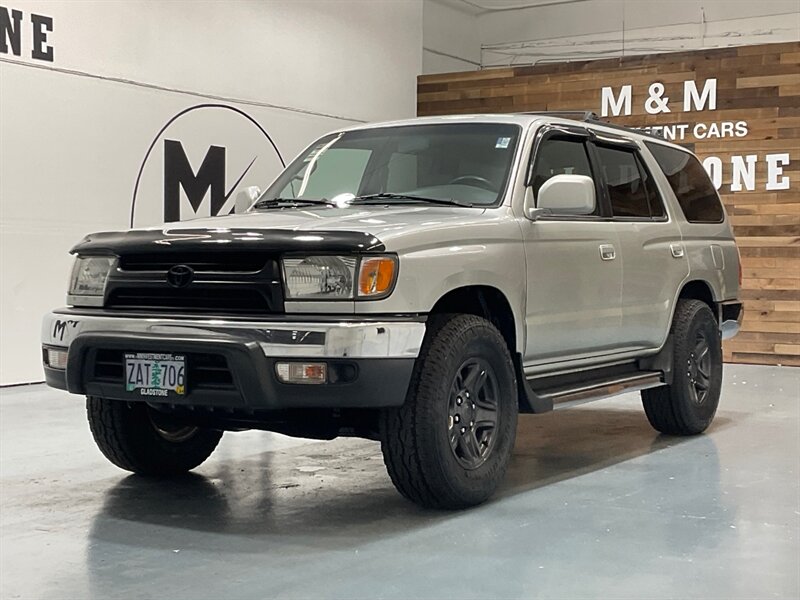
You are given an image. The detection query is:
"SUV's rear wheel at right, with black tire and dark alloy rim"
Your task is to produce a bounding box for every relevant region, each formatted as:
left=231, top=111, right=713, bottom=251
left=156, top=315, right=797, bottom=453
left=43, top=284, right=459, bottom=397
left=642, top=300, right=722, bottom=435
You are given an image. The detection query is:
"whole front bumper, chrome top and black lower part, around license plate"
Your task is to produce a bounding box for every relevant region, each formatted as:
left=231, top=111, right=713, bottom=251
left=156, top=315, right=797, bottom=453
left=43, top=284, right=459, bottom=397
left=41, top=309, right=425, bottom=410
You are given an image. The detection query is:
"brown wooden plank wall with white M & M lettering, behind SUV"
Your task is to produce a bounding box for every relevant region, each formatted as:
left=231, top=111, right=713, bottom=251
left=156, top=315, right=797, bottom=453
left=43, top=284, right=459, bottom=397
left=417, top=42, right=800, bottom=365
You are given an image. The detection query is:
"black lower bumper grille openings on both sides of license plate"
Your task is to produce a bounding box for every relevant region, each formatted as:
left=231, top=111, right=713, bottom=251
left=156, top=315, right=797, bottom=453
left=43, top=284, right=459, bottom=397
left=90, top=348, right=235, bottom=393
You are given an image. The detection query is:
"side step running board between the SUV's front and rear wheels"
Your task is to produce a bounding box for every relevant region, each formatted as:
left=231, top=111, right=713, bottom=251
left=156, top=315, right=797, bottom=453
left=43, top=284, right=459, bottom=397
left=527, top=360, right=664, bottom=410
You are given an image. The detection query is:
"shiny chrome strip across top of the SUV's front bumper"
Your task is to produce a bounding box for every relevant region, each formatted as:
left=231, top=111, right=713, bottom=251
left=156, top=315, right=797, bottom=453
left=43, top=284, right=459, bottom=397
left=41, top=312, right=425, bottom=358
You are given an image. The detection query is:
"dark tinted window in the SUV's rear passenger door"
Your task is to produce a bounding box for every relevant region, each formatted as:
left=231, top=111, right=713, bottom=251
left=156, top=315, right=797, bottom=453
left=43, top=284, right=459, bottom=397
left=597, top=146, right=650, bottom=219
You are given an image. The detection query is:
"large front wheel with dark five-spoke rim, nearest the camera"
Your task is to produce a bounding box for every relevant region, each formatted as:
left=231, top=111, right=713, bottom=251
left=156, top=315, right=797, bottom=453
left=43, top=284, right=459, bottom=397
left=380, top=315, right=518, bottom=509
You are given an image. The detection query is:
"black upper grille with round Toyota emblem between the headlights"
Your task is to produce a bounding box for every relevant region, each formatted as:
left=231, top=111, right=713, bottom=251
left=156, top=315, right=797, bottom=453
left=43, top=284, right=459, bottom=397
left=105, top=249, right=283, bottom=315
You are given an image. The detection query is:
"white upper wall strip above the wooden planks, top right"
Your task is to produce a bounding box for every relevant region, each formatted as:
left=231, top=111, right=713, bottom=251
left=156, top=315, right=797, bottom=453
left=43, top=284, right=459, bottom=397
left=423, top=0, right=800, bottom=73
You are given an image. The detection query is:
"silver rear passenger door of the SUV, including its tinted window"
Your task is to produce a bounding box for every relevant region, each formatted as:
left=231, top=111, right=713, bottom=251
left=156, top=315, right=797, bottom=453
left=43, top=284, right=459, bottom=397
left=593, top=135, right=689, bottom=350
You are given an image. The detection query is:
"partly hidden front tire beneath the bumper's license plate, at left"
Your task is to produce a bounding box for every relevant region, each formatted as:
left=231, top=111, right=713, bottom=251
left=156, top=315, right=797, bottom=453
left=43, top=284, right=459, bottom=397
left=86, top=396, right=222, bottom=475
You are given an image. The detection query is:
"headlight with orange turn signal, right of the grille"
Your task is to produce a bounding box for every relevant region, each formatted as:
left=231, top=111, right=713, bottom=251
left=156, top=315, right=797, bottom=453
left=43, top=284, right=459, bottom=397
left=283, top=256, right=397, bottom=300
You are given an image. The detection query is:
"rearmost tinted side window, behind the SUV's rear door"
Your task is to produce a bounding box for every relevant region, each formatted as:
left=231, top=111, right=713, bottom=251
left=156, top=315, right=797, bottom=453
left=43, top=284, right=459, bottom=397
left=645, top=142, right=725, bottom=223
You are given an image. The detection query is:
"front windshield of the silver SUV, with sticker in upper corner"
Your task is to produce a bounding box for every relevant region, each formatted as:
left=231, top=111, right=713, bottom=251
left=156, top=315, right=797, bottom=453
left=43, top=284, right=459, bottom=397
left=261, top=123, right=520, bottom=206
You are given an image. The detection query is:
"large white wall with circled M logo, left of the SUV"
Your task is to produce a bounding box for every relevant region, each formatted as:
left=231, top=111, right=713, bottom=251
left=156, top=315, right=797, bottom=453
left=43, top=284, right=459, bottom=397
left=0, top=0, right=422, bottom=384
